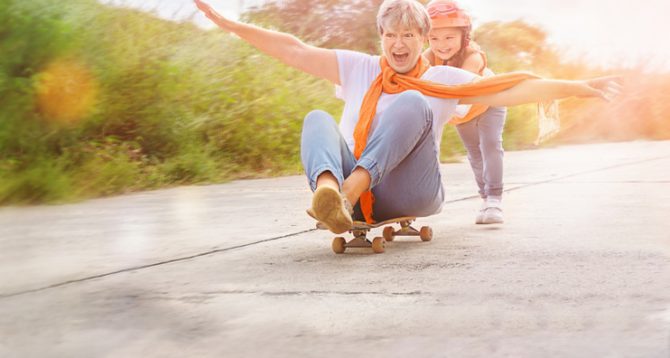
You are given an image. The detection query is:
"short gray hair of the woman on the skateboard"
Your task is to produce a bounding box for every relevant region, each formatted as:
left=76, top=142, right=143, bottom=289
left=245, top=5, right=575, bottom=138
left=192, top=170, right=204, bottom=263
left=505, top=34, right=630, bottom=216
left=377, top=0, right=430, bottom=36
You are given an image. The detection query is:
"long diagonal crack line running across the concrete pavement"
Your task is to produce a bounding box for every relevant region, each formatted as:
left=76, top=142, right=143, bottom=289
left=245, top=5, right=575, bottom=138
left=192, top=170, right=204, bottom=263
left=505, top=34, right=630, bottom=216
left=0, top=152, right=670, bottom=299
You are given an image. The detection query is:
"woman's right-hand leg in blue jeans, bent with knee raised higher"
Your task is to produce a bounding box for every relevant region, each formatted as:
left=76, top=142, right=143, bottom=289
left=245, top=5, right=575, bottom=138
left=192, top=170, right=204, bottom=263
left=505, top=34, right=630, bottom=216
left=357, top=91, right=444, bottom=221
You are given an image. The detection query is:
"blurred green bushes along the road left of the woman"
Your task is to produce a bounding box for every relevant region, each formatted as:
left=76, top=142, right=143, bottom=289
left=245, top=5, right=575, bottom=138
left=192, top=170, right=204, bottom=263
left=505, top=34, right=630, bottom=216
left=0, top=0, right=341, bottom=204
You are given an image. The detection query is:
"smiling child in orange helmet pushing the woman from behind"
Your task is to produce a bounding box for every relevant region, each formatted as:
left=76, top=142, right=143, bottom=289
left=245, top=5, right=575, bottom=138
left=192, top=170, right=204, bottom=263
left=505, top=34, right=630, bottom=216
left=424, top=0, right=507, bottom=224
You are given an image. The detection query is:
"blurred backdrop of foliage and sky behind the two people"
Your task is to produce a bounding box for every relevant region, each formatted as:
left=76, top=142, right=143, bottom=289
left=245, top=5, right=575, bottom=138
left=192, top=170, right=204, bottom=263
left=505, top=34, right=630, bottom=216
left=0, top=0, right=670, bottom=205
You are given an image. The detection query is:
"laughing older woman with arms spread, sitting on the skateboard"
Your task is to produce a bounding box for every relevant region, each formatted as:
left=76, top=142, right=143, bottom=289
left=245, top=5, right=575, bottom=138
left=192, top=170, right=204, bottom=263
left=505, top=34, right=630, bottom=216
left=195, top=0, right=619, bottom=233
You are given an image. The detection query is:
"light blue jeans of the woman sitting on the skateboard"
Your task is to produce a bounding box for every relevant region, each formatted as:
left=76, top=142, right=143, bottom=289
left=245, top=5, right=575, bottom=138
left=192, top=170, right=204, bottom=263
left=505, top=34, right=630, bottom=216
left=300, top=91, right=444, bottom=221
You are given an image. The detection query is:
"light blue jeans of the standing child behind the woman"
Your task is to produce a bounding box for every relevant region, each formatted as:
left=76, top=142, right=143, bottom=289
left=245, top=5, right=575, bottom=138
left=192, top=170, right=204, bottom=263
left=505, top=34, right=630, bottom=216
left=456, top=107, right=507, bottom=198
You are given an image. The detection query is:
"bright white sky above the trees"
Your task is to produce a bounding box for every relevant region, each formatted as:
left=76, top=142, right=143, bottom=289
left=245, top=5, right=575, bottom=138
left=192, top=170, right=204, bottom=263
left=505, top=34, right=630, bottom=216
left=99, top=0, right=670, bottom=72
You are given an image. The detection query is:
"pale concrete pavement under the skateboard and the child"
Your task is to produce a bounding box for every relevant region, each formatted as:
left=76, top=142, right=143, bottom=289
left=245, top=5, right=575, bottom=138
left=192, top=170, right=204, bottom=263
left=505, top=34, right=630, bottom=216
left=0, top=142, right=670, bottom=357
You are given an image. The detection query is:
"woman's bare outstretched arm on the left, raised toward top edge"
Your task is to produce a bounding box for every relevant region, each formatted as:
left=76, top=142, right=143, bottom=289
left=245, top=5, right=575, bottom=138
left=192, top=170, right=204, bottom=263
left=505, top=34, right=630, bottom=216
left=194, top=0, right=340, bottom=85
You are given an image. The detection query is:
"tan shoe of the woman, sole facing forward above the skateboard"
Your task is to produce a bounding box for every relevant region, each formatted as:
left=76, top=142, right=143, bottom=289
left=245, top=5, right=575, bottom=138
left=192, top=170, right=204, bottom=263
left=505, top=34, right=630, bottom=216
left=312, top=186, right=354, bottom=234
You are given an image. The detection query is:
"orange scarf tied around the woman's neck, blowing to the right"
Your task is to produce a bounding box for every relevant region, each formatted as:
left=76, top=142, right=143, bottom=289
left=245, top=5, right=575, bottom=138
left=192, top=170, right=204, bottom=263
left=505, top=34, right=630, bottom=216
left=354, top=56, right=538, bottom=224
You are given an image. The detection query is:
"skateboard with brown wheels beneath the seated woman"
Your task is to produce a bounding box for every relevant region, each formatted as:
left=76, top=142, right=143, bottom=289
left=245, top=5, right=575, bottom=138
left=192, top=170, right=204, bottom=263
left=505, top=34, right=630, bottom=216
left=316, top=216, right=433, bottom=254
